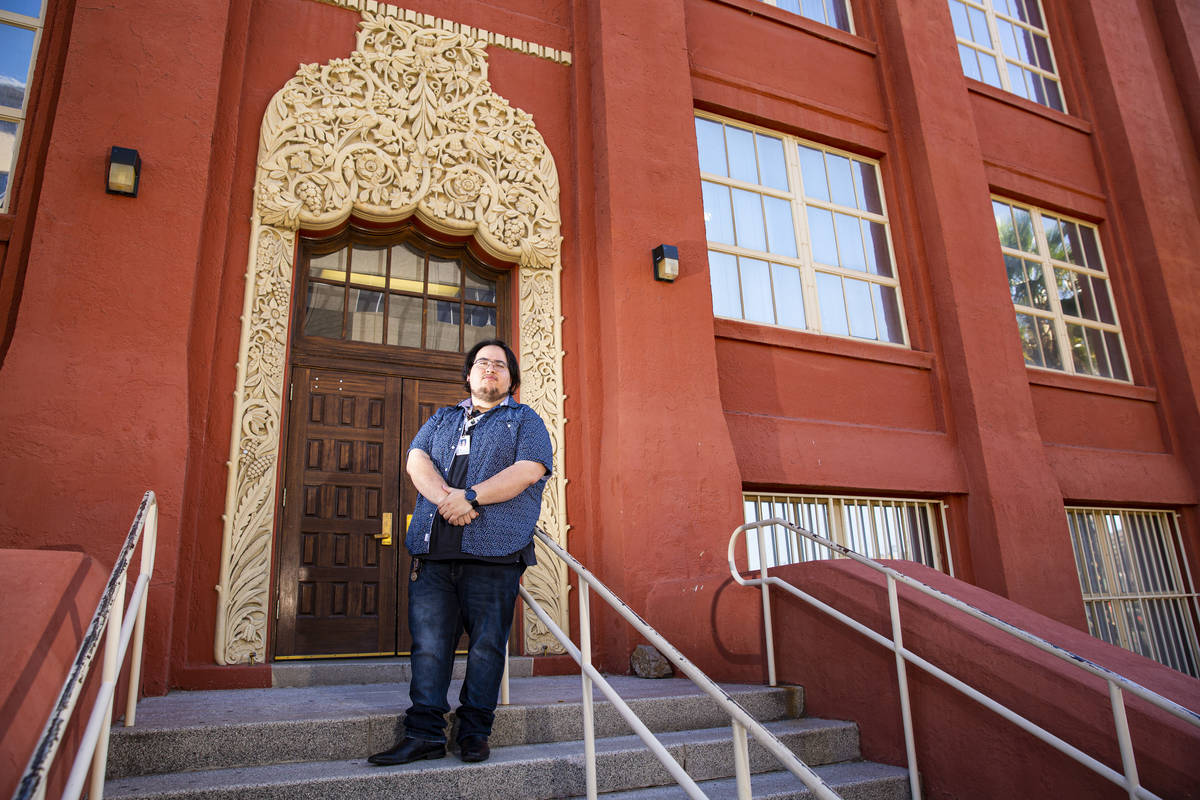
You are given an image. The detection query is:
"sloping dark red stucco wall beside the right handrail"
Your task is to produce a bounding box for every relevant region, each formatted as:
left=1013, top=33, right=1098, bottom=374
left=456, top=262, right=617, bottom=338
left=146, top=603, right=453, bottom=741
left=768, top=559, right=1200, bottom=800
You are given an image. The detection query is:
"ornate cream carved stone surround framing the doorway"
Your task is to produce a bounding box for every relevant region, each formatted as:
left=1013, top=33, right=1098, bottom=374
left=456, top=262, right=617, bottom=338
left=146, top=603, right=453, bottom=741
left=215, top=9, right=570, bottom=664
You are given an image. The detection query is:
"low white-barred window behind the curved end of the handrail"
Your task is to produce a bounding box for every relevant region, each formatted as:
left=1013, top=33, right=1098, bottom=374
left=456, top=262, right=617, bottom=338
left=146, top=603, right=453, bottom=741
left=743, top=494, right=954, bottom=576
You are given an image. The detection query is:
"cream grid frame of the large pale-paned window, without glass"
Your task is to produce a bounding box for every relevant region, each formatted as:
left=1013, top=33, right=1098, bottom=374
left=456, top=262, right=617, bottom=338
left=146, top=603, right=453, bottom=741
left=694, top=109, right=912, bottom=349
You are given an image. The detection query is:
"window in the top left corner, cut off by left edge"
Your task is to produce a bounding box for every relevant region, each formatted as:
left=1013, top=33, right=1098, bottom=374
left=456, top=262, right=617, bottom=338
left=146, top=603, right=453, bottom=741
left=0, top=0, right=44, bottom=212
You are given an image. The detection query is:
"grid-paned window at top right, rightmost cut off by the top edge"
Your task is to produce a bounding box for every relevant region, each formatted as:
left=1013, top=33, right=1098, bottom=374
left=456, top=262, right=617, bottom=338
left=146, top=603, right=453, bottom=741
left=949, top=0, right=1067, bottom=112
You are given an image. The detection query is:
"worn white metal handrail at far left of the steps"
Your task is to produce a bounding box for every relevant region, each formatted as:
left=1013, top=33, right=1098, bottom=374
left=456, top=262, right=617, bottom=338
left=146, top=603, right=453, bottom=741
left=12, top=492, right=158, bottom=800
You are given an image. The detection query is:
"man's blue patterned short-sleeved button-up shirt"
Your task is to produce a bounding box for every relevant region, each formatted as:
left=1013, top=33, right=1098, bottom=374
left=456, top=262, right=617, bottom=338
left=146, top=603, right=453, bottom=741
left=404, top=395, right=553, bottom=555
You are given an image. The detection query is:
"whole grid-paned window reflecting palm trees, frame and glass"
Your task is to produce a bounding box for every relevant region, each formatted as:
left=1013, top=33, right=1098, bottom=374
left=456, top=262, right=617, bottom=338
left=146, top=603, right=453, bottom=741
left=991, top=198, right=1129, bottom=380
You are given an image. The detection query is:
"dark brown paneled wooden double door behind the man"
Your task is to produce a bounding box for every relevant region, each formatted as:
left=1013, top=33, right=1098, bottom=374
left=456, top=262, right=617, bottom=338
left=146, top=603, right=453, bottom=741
left=275, top=366, right=464, bottom=658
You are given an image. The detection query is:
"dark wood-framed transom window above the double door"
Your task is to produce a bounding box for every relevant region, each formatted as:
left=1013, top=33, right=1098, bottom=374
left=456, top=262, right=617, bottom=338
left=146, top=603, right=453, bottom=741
left=300, top=236, right=502, bottom=353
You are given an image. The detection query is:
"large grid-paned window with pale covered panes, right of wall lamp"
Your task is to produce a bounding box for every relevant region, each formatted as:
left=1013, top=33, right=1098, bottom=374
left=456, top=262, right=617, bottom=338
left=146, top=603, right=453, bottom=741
left=696, top=115, right=907, bottom=344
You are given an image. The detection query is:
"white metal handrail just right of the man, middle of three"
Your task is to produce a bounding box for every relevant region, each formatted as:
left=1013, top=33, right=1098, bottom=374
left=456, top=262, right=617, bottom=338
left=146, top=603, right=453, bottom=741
left=502, top=530, right=839, bottom=800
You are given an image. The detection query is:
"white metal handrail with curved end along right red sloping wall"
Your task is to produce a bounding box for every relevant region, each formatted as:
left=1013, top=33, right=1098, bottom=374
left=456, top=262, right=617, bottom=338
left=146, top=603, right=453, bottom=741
left=728, top=518, right=1200, bottom=800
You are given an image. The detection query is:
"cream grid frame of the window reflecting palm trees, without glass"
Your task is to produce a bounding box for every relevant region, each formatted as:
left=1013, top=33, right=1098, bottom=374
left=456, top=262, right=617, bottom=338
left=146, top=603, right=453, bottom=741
left=990, top=194, right=1134, bottom=385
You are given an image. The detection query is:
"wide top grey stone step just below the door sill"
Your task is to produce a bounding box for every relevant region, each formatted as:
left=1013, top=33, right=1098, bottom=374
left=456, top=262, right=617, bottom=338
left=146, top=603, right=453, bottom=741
left=107, top=675, right=804, bottom=778
